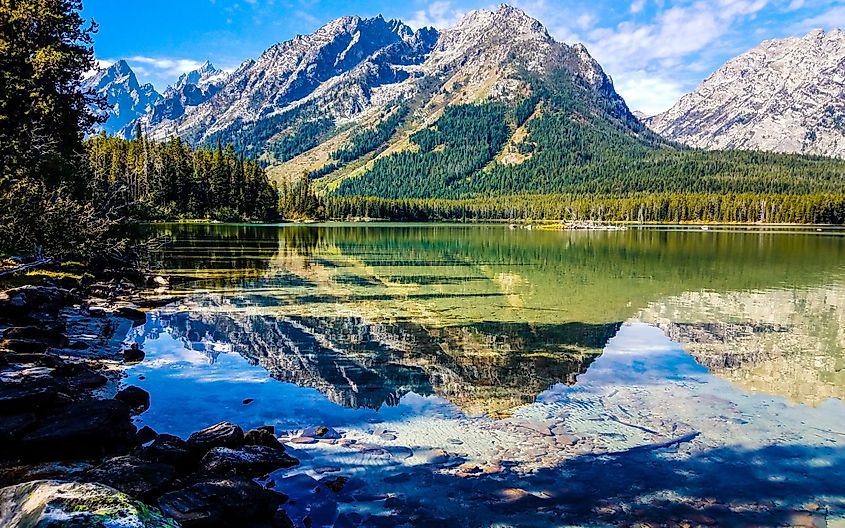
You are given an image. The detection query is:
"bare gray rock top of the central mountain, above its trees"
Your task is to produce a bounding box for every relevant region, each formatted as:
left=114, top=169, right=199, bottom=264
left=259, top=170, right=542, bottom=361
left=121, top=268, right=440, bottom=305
left=137, top=5, right=628, bottom=153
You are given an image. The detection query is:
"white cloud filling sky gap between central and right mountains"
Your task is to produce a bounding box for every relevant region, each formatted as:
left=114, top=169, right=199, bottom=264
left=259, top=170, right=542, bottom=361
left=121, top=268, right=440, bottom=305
left=502, top=0, right=784, bottom=114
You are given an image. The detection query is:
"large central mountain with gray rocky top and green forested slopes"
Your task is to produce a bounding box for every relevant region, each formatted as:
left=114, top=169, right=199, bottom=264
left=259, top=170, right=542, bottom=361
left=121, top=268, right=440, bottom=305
left=87, top=5, right=845, bottom=202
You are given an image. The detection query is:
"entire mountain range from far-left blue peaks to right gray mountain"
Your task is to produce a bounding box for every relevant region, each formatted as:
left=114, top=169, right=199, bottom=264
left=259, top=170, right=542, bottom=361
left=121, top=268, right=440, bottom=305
left=84, top=5, right=845, bottom=198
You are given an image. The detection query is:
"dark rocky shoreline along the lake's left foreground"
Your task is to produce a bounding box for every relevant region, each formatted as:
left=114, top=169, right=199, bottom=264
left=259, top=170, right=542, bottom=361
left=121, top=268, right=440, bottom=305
left=0, top=271, right=310, bottom=527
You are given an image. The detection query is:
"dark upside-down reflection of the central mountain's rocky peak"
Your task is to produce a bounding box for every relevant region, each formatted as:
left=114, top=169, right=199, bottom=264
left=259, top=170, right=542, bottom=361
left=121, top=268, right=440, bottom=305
left=137, top=311, right=621, bottom=416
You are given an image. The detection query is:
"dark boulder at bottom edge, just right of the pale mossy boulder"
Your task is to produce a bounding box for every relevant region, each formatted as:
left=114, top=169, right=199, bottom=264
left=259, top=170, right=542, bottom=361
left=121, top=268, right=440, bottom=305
left=158, top=480, right=284, bottom=528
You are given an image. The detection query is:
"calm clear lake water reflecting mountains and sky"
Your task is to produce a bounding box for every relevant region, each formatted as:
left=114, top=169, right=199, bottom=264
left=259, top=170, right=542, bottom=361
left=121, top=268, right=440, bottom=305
left=126, top=224, right=845, bottom=526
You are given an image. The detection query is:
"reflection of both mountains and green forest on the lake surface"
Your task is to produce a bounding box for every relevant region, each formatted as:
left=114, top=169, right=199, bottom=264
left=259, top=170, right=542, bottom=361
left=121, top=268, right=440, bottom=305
left=132, top=221, right=845, bottom=410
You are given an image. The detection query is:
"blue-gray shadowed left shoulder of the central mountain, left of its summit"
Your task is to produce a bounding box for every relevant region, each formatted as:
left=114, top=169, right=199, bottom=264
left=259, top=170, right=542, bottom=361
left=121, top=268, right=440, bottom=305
left=153, top=17, right=436, bottom=142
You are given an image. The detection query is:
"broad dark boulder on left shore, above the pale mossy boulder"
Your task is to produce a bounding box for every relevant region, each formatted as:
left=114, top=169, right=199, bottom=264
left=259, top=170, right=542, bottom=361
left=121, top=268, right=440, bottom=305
left=21, top=400, right=138, bottom=460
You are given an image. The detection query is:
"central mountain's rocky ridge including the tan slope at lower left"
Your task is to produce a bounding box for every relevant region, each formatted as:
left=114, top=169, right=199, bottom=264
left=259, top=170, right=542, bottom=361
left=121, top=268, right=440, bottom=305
left=94, top=5, right=630, bottom=179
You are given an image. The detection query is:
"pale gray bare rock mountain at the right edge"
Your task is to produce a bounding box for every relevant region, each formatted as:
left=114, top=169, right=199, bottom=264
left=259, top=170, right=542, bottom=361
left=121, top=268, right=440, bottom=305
left=646, top=29, right=845, bottom=158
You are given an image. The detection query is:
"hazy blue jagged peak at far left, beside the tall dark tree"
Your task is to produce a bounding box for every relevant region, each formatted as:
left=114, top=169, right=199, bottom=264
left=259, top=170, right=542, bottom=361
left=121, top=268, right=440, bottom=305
left=83, top=60, right=162, bottom=134
